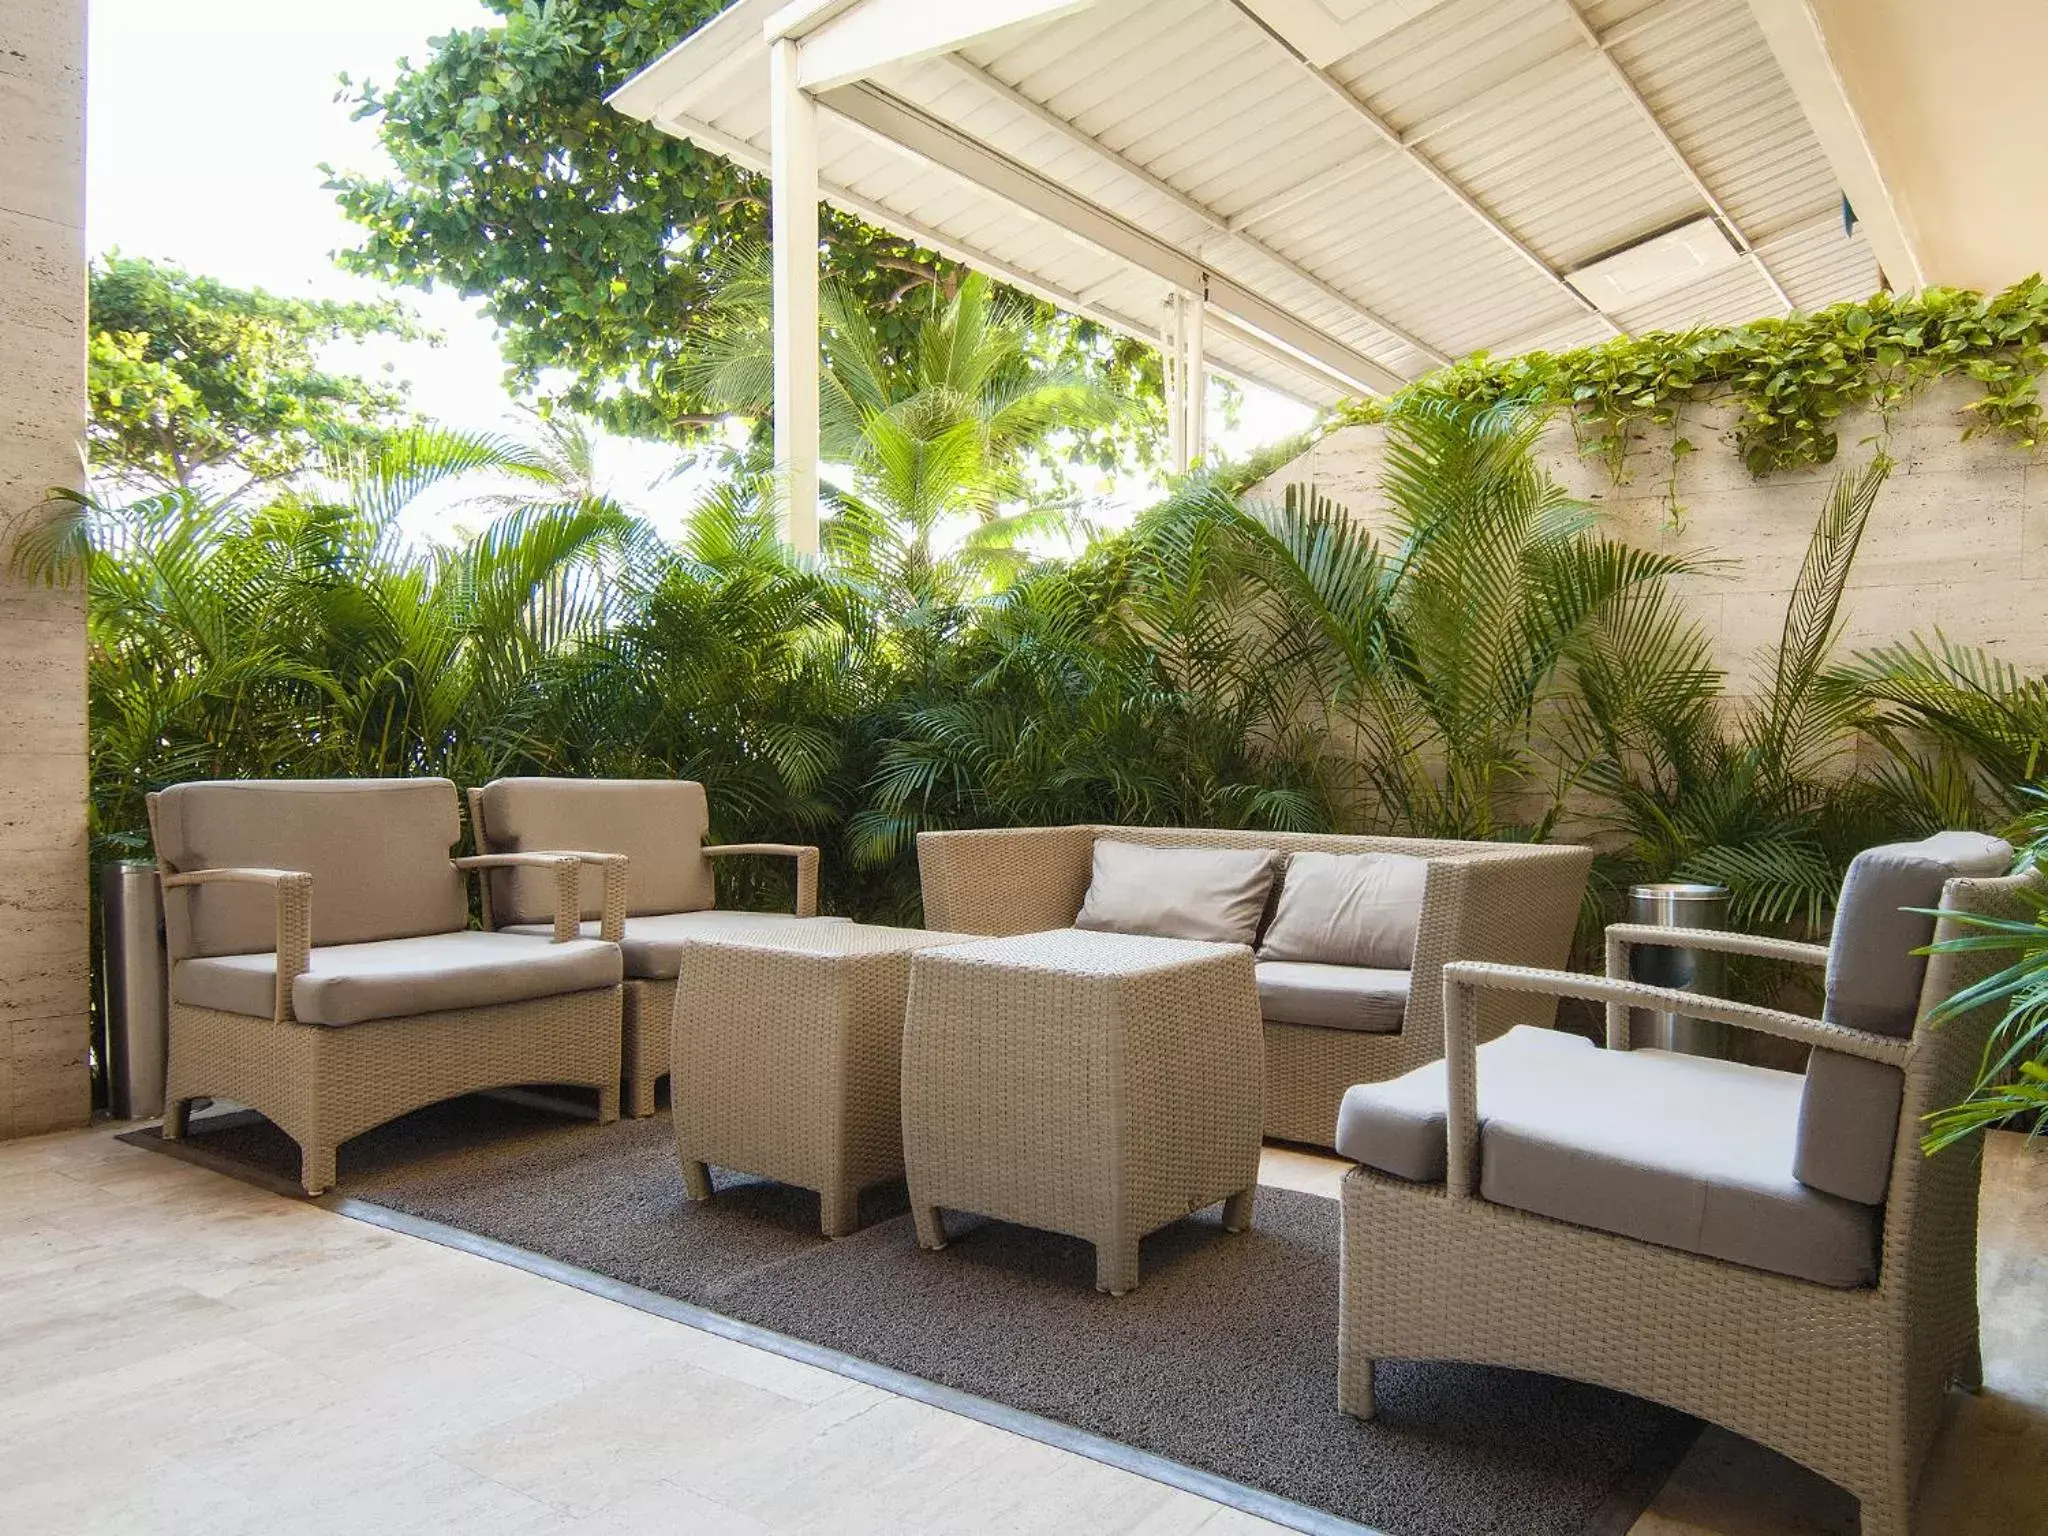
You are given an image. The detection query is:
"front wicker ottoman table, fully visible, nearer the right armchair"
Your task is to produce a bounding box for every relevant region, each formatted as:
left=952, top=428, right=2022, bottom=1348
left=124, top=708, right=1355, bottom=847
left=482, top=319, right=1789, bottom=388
left=903, top=928, right=1266, bottom=1296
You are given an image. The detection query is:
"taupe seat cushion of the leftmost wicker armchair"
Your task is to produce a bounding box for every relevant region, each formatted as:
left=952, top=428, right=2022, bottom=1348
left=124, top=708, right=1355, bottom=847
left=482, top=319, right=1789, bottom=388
left=170, top=932, right=623, bottom=1024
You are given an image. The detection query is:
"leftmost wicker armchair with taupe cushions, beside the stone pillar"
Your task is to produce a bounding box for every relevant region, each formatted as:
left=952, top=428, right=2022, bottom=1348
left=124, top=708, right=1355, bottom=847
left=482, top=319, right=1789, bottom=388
left=150, top=778, right=625, bottom=1194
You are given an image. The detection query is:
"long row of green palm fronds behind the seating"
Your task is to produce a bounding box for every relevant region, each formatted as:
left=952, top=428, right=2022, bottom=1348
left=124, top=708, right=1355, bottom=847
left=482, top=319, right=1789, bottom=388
left=28, top=374, right=2042, bottom=928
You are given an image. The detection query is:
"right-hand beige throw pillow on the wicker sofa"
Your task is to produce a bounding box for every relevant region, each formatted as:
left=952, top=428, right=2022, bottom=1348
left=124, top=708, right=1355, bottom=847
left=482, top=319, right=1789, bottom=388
left=1260, top=852, right=1430, bottom=971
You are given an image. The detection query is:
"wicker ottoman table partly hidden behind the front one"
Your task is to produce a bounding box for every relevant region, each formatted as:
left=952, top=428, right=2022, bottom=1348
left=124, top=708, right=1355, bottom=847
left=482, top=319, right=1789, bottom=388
left=670, top=924, right=963, bottom=1237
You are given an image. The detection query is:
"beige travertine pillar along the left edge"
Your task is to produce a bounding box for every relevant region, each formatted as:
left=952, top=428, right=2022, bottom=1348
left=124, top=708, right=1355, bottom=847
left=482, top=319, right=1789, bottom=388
left=0, top=0, right=92, bottom=1137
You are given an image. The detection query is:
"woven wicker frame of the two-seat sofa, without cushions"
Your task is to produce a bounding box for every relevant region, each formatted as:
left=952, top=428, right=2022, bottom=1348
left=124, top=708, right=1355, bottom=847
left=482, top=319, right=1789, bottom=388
left=918, top=825, right=1593, bottom=1147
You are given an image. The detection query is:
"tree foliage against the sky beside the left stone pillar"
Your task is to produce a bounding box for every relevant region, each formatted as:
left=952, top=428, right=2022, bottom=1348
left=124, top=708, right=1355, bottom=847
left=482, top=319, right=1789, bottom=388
left=88, top=254, right=420, bottom=496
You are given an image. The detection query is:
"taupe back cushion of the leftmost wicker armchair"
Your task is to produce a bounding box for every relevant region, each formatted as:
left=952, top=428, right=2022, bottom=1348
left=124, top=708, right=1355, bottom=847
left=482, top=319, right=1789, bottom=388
left=156, top=778, right=469, bottom=958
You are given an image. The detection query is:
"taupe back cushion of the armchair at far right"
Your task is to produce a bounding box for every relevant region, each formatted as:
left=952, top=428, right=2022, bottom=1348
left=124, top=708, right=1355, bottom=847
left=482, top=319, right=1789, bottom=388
left=1792, top=831, right=2013, bottom=1204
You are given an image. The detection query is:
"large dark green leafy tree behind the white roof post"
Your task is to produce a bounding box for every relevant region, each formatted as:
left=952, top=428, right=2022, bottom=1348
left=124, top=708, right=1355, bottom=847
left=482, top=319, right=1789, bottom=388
left=330, top=0, right=1159, bottom=467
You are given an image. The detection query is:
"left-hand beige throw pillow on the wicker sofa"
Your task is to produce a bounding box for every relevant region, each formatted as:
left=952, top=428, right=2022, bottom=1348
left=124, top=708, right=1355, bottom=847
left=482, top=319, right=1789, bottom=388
left=1073, top=838, right=1278, bottom=944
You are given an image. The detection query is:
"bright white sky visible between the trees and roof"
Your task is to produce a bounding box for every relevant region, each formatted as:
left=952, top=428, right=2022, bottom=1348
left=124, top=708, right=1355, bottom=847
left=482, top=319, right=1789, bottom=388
left=86, top=0, right=1309, bottom=536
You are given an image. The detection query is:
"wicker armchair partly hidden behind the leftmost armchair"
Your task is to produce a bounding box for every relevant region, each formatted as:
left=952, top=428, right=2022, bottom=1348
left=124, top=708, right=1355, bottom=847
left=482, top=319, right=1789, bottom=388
left=469, top=778, right=838, bottom=1116
